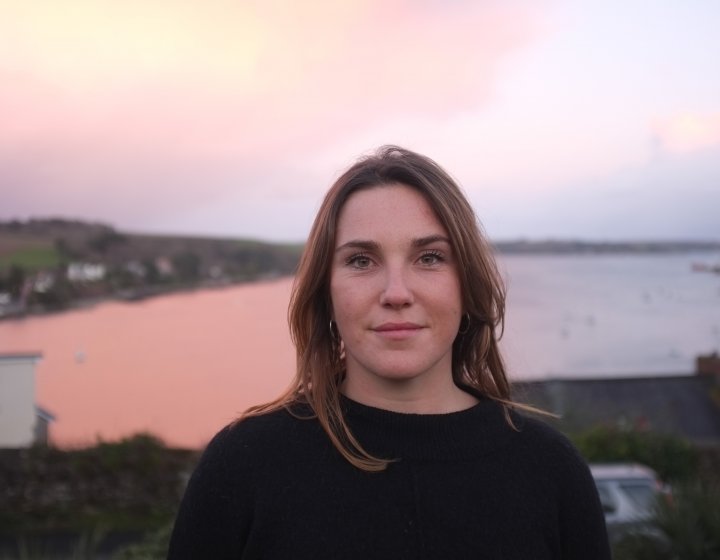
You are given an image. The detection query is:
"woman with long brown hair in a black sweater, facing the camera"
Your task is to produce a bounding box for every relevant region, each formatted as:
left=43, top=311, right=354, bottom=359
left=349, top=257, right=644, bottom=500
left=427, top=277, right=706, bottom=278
left=169, top=146, right=610, bottom=560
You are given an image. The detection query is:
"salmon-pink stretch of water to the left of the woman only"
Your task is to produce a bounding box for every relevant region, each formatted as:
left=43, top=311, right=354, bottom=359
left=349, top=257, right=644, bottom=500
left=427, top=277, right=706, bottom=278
left=0, top=279, right=295, bottom=447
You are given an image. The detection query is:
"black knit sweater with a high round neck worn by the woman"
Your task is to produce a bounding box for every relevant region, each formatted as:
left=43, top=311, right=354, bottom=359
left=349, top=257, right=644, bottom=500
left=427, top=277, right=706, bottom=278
left=168, top=399, right=610, bottom=560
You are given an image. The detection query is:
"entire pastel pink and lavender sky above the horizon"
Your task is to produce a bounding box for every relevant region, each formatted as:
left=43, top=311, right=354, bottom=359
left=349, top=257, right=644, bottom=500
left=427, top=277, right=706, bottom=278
left=0, top=0, right=720, bottom=241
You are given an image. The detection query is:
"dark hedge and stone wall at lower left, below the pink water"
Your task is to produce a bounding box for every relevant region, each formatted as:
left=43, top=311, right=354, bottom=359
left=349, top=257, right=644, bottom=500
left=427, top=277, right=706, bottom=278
left=0, top=434, right=197, bottom=535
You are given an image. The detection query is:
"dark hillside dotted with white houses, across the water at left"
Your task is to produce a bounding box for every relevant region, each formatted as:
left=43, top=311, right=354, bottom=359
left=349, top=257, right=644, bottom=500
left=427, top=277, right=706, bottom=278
left=0, top=219, right=302, bottom=317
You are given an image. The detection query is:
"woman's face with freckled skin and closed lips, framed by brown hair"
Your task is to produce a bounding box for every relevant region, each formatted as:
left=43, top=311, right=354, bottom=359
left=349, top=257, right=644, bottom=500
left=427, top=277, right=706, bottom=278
left=330, top=184, right=463, bottom=401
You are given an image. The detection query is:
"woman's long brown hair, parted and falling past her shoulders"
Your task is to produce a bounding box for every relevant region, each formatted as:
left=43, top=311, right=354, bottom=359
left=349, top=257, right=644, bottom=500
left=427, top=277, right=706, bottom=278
left=244, top=146, right=513, bottom=471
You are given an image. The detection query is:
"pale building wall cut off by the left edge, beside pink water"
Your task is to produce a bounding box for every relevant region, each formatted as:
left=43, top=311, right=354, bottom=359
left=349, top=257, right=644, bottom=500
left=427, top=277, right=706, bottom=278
left=0, top=353, right=42, bottom=448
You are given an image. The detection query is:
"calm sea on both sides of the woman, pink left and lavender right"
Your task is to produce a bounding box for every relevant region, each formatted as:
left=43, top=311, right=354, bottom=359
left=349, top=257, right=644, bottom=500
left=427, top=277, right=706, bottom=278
left=0, top=252, right=720, bottom=448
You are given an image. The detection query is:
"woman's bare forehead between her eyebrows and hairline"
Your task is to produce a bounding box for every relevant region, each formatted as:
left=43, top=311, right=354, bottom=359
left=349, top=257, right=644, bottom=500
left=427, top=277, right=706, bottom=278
left=336, top=183, right=447, bottom=244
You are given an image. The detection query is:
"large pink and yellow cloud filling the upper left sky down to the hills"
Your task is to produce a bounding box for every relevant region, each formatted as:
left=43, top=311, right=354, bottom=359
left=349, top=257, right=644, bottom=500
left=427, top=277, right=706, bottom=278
left=0, top=0, right=537, bottom=232
